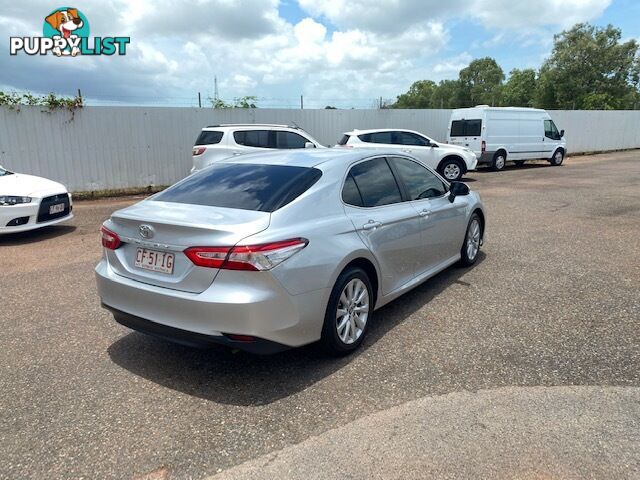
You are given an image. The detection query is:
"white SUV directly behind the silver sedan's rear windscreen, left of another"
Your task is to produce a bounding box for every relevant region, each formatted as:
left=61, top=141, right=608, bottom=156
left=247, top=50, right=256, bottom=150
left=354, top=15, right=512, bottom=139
left=191, top=123, right=322, bottom=173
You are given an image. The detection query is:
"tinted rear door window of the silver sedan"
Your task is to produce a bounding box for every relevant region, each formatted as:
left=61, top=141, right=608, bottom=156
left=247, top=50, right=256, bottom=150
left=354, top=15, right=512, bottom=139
left=349, top=158, right=402, bottom=207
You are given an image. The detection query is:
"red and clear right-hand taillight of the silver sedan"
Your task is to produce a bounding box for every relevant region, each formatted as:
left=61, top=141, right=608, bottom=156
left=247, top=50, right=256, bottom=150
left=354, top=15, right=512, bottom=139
left=184, top=238, right=309, bottom=271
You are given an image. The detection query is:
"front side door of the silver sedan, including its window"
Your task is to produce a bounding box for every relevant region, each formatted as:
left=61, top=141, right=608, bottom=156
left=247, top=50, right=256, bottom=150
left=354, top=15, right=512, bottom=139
left=389, top=157, right=467, bottom=275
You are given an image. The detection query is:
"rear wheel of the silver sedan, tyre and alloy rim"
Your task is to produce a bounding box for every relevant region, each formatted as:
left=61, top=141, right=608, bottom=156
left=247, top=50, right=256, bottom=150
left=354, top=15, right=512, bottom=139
left=321, top=267, right=374, bottom=356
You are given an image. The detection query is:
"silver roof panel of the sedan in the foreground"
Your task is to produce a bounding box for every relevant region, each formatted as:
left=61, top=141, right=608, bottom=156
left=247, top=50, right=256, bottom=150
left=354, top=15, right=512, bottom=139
left=216, top=147, right=398, bottom=167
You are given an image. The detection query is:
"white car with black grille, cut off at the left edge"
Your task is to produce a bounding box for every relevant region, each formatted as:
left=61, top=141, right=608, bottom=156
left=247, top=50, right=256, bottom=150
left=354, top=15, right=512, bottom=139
left=0, top=166, right=73, bottom=235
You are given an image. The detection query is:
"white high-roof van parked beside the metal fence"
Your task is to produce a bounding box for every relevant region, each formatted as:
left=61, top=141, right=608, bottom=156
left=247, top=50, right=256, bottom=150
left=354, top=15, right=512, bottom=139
left=447, top=105, right=567, bottom=170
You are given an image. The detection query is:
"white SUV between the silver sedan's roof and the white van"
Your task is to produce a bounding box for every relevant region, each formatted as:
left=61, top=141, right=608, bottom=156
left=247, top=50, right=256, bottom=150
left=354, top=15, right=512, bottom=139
left=337, top=129, right=478, bottom=182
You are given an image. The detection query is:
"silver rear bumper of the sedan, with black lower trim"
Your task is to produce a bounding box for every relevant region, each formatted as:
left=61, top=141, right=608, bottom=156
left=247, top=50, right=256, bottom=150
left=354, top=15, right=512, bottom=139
left=96, top=259, right=326, bottom=351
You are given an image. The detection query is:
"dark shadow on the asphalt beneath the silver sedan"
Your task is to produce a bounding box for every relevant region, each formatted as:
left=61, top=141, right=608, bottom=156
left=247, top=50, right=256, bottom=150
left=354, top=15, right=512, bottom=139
left=108, top=252, right=485, bottom=406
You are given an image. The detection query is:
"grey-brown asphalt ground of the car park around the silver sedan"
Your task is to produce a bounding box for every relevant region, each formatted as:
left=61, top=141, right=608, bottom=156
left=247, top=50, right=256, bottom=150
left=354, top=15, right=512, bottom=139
left=0, top=151, right=640, bottom=479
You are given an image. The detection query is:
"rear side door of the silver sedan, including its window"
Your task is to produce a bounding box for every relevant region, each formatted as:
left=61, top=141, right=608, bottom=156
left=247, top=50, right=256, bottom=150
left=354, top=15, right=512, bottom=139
left=342, top=157, right=422, bottom=295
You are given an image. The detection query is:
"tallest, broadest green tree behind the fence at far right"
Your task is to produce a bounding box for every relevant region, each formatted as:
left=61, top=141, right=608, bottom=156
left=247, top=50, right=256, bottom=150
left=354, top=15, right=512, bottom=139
left=536, top=23, right=640, bottom=110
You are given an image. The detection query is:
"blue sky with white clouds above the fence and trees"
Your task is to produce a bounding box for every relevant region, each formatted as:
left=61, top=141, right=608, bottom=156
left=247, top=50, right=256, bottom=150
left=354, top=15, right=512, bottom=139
left=0, top=0, right=640, bottom=108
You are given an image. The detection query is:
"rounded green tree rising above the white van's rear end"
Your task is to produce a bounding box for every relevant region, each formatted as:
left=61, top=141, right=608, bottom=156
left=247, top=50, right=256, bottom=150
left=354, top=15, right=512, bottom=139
left=457, top=57, right=504, bottom=107
